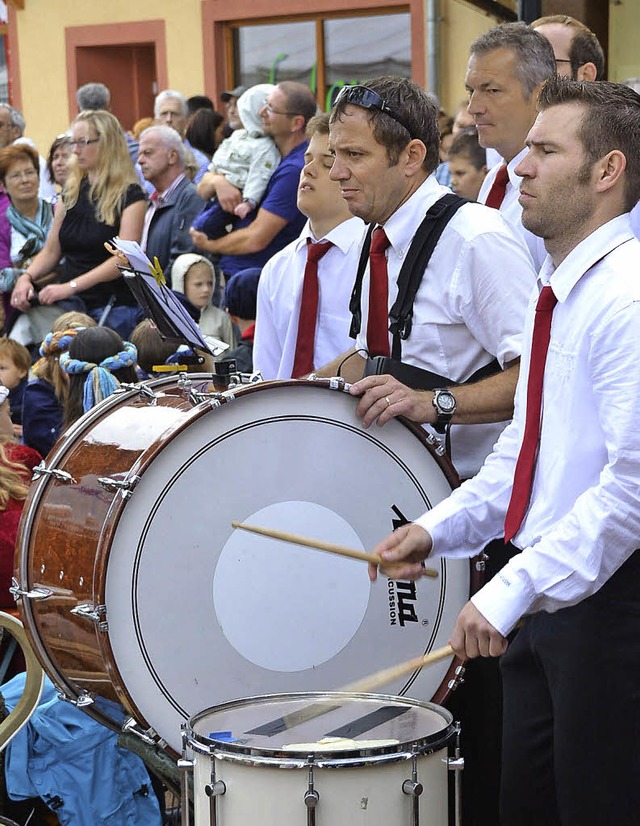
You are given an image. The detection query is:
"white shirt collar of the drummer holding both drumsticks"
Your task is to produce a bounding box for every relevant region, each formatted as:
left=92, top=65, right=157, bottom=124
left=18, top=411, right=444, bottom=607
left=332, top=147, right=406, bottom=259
left=538, top=212, right=635, bottom=303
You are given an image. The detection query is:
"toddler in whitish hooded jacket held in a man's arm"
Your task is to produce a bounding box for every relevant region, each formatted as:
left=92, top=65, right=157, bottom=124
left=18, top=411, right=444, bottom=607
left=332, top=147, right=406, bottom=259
left=193, top=83, right=280, bottom=238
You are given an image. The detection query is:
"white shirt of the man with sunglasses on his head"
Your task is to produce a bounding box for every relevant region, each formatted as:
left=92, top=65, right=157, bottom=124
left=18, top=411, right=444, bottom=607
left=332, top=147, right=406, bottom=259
left=356, top=175, right=535, bottom=478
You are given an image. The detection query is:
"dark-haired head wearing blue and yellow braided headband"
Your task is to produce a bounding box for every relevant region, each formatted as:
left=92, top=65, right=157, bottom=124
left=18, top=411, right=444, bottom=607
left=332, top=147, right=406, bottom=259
left=60, top=327, right=138, bottom=427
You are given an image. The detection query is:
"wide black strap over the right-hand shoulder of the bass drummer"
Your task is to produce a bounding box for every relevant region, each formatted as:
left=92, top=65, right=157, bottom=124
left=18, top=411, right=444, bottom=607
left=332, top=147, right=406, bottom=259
left=389, top=193, right=468, bottom=360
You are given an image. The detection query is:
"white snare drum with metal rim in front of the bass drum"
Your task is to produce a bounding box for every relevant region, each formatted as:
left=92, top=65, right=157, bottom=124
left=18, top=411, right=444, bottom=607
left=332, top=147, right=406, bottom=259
left=183, top=692, right=456, bottom=826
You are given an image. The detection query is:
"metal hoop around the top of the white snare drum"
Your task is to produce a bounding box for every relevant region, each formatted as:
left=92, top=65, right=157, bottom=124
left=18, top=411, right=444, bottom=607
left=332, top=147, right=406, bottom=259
left=182, top=691, right=457, bottom=768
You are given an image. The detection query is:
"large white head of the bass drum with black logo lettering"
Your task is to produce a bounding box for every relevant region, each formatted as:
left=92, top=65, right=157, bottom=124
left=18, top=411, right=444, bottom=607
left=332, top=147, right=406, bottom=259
left=105, top=382, right=469, bottom=752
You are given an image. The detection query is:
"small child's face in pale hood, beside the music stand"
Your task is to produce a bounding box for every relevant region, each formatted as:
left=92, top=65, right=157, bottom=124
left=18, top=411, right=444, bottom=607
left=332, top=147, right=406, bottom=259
left=171, top=252, right=235, bottom=347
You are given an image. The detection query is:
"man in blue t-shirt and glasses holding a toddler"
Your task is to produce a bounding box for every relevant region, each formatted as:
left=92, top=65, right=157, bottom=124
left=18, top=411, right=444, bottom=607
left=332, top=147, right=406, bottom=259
left=191, top=80, right=317, bottom=277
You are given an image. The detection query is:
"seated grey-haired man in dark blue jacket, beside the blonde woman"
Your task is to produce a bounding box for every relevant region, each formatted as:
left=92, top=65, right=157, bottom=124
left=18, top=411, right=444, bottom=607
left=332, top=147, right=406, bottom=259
left=138, top=126, right=204, bottom=280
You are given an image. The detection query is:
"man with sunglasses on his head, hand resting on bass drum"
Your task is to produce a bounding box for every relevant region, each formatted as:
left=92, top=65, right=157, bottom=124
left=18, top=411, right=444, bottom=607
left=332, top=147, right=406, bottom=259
left=319, top=77, right=535, bottom=826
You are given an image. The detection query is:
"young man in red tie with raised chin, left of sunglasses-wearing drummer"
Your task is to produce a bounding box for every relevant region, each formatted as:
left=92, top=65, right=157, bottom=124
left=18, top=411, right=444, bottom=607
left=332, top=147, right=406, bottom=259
left=253, top=115, right=364, bottom=379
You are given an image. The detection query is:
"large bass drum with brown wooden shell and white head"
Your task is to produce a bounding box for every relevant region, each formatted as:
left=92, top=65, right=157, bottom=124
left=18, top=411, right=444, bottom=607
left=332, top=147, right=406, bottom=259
left=16, top=377, right=470, bottom=754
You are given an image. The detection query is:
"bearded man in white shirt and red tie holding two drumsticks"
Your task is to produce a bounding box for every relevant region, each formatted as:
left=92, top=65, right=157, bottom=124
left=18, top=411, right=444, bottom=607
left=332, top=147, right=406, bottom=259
left=372, top=78, right=640, bottom=826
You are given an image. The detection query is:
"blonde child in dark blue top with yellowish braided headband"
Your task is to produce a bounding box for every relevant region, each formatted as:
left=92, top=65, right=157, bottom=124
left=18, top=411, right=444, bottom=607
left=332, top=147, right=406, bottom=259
left=22, top=310, right=96, bottom=456
